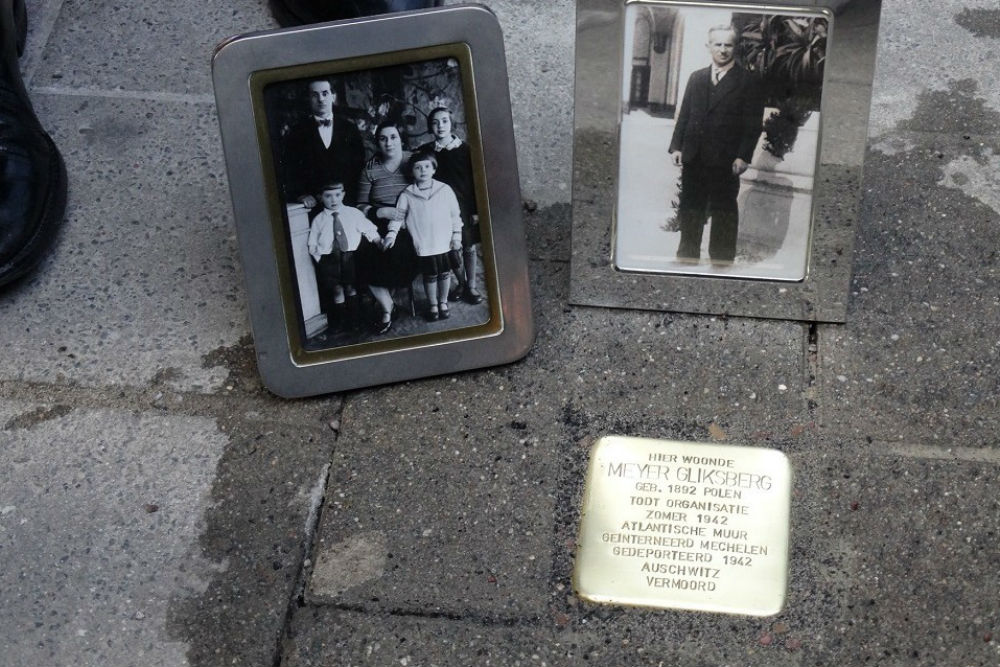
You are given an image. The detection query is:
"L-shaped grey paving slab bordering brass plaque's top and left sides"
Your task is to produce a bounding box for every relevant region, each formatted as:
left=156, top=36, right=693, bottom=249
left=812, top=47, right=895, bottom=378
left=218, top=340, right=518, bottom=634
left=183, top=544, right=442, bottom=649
left=309, top=262, right=810, bottom=619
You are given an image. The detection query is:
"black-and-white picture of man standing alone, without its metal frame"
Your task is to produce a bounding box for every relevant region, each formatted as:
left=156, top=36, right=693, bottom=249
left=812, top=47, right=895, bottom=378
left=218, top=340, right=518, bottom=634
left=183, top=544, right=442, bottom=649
left=614, top=2, right=831, bottom=281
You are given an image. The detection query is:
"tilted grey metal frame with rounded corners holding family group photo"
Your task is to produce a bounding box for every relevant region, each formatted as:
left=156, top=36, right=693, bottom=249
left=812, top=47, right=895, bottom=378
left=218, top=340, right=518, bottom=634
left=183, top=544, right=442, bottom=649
left=213, top=6, right=533, bottom=397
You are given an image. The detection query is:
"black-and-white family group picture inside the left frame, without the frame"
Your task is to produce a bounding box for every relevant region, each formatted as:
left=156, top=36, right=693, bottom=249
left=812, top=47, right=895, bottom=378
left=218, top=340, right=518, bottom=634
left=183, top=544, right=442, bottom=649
left=264, top=58, right=491, bottom=350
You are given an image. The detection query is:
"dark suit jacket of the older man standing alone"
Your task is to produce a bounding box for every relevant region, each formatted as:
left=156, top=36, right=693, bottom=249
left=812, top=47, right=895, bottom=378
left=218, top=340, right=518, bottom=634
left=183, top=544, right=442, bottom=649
left=670, top=65, right=764, bottom=167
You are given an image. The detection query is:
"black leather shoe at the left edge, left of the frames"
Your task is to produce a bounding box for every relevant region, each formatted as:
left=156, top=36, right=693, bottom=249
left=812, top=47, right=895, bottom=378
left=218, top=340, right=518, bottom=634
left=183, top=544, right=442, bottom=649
left=0, top=0, right=66, bottom=285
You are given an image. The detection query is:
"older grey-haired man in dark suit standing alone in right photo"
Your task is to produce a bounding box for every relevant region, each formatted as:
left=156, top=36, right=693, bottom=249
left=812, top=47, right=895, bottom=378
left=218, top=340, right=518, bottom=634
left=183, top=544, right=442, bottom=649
left=670, top=25, right=764, bottom=264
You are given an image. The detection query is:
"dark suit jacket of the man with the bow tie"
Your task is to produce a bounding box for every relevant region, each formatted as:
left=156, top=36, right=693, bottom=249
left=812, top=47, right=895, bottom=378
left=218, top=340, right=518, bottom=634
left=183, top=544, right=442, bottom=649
left=281, top=116, right=365, bottom=205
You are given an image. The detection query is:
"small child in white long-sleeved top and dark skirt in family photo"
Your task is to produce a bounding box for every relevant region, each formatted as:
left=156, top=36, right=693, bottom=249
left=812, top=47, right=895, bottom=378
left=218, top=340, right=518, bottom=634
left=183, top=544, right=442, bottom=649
left=396, top=152, right=462, bottom=322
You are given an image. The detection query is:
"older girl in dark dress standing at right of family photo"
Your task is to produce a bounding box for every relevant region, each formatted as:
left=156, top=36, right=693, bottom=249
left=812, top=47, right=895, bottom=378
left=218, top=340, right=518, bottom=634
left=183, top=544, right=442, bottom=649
left=420, top=107, right=483, bottom=304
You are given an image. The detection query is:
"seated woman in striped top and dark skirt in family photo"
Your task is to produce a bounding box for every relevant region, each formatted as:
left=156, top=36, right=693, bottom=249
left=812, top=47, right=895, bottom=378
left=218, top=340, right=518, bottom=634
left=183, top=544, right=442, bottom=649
left=358, top=121, right=417, bottom=334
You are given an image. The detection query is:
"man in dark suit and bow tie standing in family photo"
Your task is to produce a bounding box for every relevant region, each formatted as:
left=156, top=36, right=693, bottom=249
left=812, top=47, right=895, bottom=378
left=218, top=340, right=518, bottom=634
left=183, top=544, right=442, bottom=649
left=281, top=79, right=365, bottom=209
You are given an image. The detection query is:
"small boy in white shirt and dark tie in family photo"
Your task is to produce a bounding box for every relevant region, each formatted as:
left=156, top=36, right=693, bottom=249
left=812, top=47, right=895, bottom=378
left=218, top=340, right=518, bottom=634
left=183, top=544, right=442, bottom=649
left=308, top=182, right=382, bottom=327
